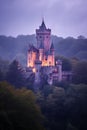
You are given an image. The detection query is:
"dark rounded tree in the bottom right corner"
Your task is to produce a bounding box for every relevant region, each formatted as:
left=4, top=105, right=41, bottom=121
left=65, top=84, right=87, bottom=130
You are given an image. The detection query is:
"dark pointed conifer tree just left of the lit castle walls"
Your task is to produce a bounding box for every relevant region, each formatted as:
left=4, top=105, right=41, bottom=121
left=6, top=60, right=25, bottom=87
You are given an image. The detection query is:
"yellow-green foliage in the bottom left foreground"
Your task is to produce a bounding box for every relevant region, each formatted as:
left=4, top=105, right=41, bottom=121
left=0, top=82, right=44, bottom=130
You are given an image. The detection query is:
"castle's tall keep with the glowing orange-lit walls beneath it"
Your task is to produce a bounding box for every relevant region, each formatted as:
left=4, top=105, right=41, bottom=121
left=27, top=20, right=55, bottom=69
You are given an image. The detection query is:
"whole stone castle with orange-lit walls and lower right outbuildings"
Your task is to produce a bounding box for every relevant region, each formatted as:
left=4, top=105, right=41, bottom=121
left=27, top=20, right=71, bottom=84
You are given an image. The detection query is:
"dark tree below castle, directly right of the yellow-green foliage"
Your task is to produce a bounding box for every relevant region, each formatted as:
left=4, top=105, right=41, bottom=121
left=38, top=86, right=66, bottom=130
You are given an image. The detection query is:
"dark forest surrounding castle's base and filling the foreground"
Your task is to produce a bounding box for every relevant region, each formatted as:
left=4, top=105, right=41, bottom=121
left=0, top=56, right=87, bottom=130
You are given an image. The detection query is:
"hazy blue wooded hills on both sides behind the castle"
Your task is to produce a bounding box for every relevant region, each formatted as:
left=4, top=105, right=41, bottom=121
left=0, top=35, right=87, bottom=64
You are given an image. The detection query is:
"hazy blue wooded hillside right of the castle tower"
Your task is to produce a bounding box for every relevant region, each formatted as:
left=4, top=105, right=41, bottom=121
left=54, top=37, right=87, bottom=60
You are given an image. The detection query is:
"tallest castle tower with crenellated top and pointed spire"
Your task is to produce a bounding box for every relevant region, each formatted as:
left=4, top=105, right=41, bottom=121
left=36, top=20, right=51, bottom=52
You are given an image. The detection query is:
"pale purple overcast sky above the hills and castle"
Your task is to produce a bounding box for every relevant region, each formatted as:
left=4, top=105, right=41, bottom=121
left=0, top=0, right=87, bottom=37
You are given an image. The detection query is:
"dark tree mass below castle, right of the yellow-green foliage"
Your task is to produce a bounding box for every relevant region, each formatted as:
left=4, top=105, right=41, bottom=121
left=37, top=83, right=87, bottom=130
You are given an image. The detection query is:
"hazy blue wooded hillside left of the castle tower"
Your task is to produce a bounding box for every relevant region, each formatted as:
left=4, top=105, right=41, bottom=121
left=0, top=35, right=36, bottom=65
